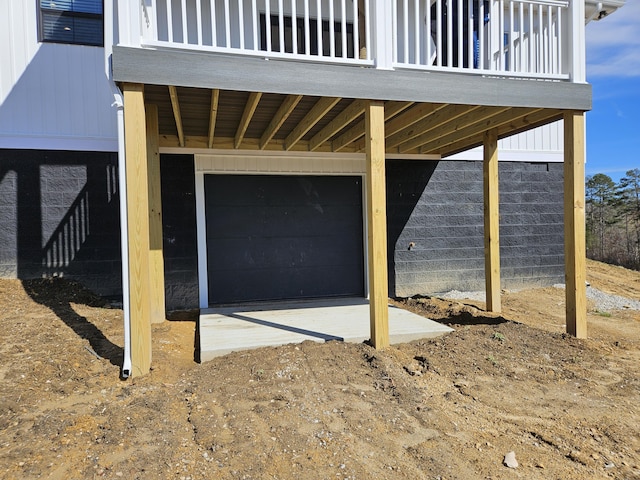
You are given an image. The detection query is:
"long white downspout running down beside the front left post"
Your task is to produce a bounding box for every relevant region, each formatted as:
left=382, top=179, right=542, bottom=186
left=104, top=0, right=131, bottom=378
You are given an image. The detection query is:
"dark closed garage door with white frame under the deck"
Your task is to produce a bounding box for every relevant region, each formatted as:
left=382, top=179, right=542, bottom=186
left=205, top=175, right=364, bottom=304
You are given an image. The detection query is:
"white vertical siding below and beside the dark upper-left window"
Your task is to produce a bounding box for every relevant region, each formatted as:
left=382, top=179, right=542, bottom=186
left=0, top=0, right=117, bottom=151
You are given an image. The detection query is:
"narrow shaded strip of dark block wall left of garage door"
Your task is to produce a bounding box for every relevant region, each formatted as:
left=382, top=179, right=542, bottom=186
left=160, top=155, right=198, bottom=310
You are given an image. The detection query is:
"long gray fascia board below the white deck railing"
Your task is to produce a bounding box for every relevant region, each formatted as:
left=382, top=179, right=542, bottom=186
left=112, top=46, right=592, bottom=111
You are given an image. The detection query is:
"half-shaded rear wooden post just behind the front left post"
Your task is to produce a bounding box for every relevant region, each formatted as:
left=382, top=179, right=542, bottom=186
left=146, top=105, right=166, bottom=323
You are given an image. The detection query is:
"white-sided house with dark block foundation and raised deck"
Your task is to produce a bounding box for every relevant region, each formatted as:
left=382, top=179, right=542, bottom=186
left=0, top=0, right=623, bottom=375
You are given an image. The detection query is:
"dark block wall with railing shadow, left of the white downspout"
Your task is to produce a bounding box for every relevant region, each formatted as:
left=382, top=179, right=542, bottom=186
left=0, top=150, right=121, bottom=296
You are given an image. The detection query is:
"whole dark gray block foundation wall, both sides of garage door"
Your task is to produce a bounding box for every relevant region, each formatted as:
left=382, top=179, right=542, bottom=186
left=0, top=150, right=564, bottom=310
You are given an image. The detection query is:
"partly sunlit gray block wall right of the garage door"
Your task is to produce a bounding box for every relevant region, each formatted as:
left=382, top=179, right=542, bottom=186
left=387, top=160, right=564, bottom=297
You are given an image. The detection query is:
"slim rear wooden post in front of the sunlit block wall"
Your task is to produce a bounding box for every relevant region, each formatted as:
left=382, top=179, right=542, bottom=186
left=482, top=129, right=502, bottom=312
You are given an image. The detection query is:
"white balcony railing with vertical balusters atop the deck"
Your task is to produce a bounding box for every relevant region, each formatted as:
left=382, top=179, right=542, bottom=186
left=117, top=0, right=584, bottom=80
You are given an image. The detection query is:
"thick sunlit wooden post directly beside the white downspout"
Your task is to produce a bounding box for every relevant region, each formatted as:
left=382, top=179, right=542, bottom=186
left=122, top=83, right=151, bottom=377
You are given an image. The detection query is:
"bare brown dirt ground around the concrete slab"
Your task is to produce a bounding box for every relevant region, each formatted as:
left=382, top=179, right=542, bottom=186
left=0, top=262, right=640, bottom=480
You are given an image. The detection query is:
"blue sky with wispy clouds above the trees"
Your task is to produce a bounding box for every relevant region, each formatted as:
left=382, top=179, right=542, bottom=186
left=586, top=0, right=640, bottom=182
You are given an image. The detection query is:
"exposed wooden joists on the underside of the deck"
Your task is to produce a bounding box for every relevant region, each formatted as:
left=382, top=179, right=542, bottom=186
left=145, top=85, right=562, bottom=157
